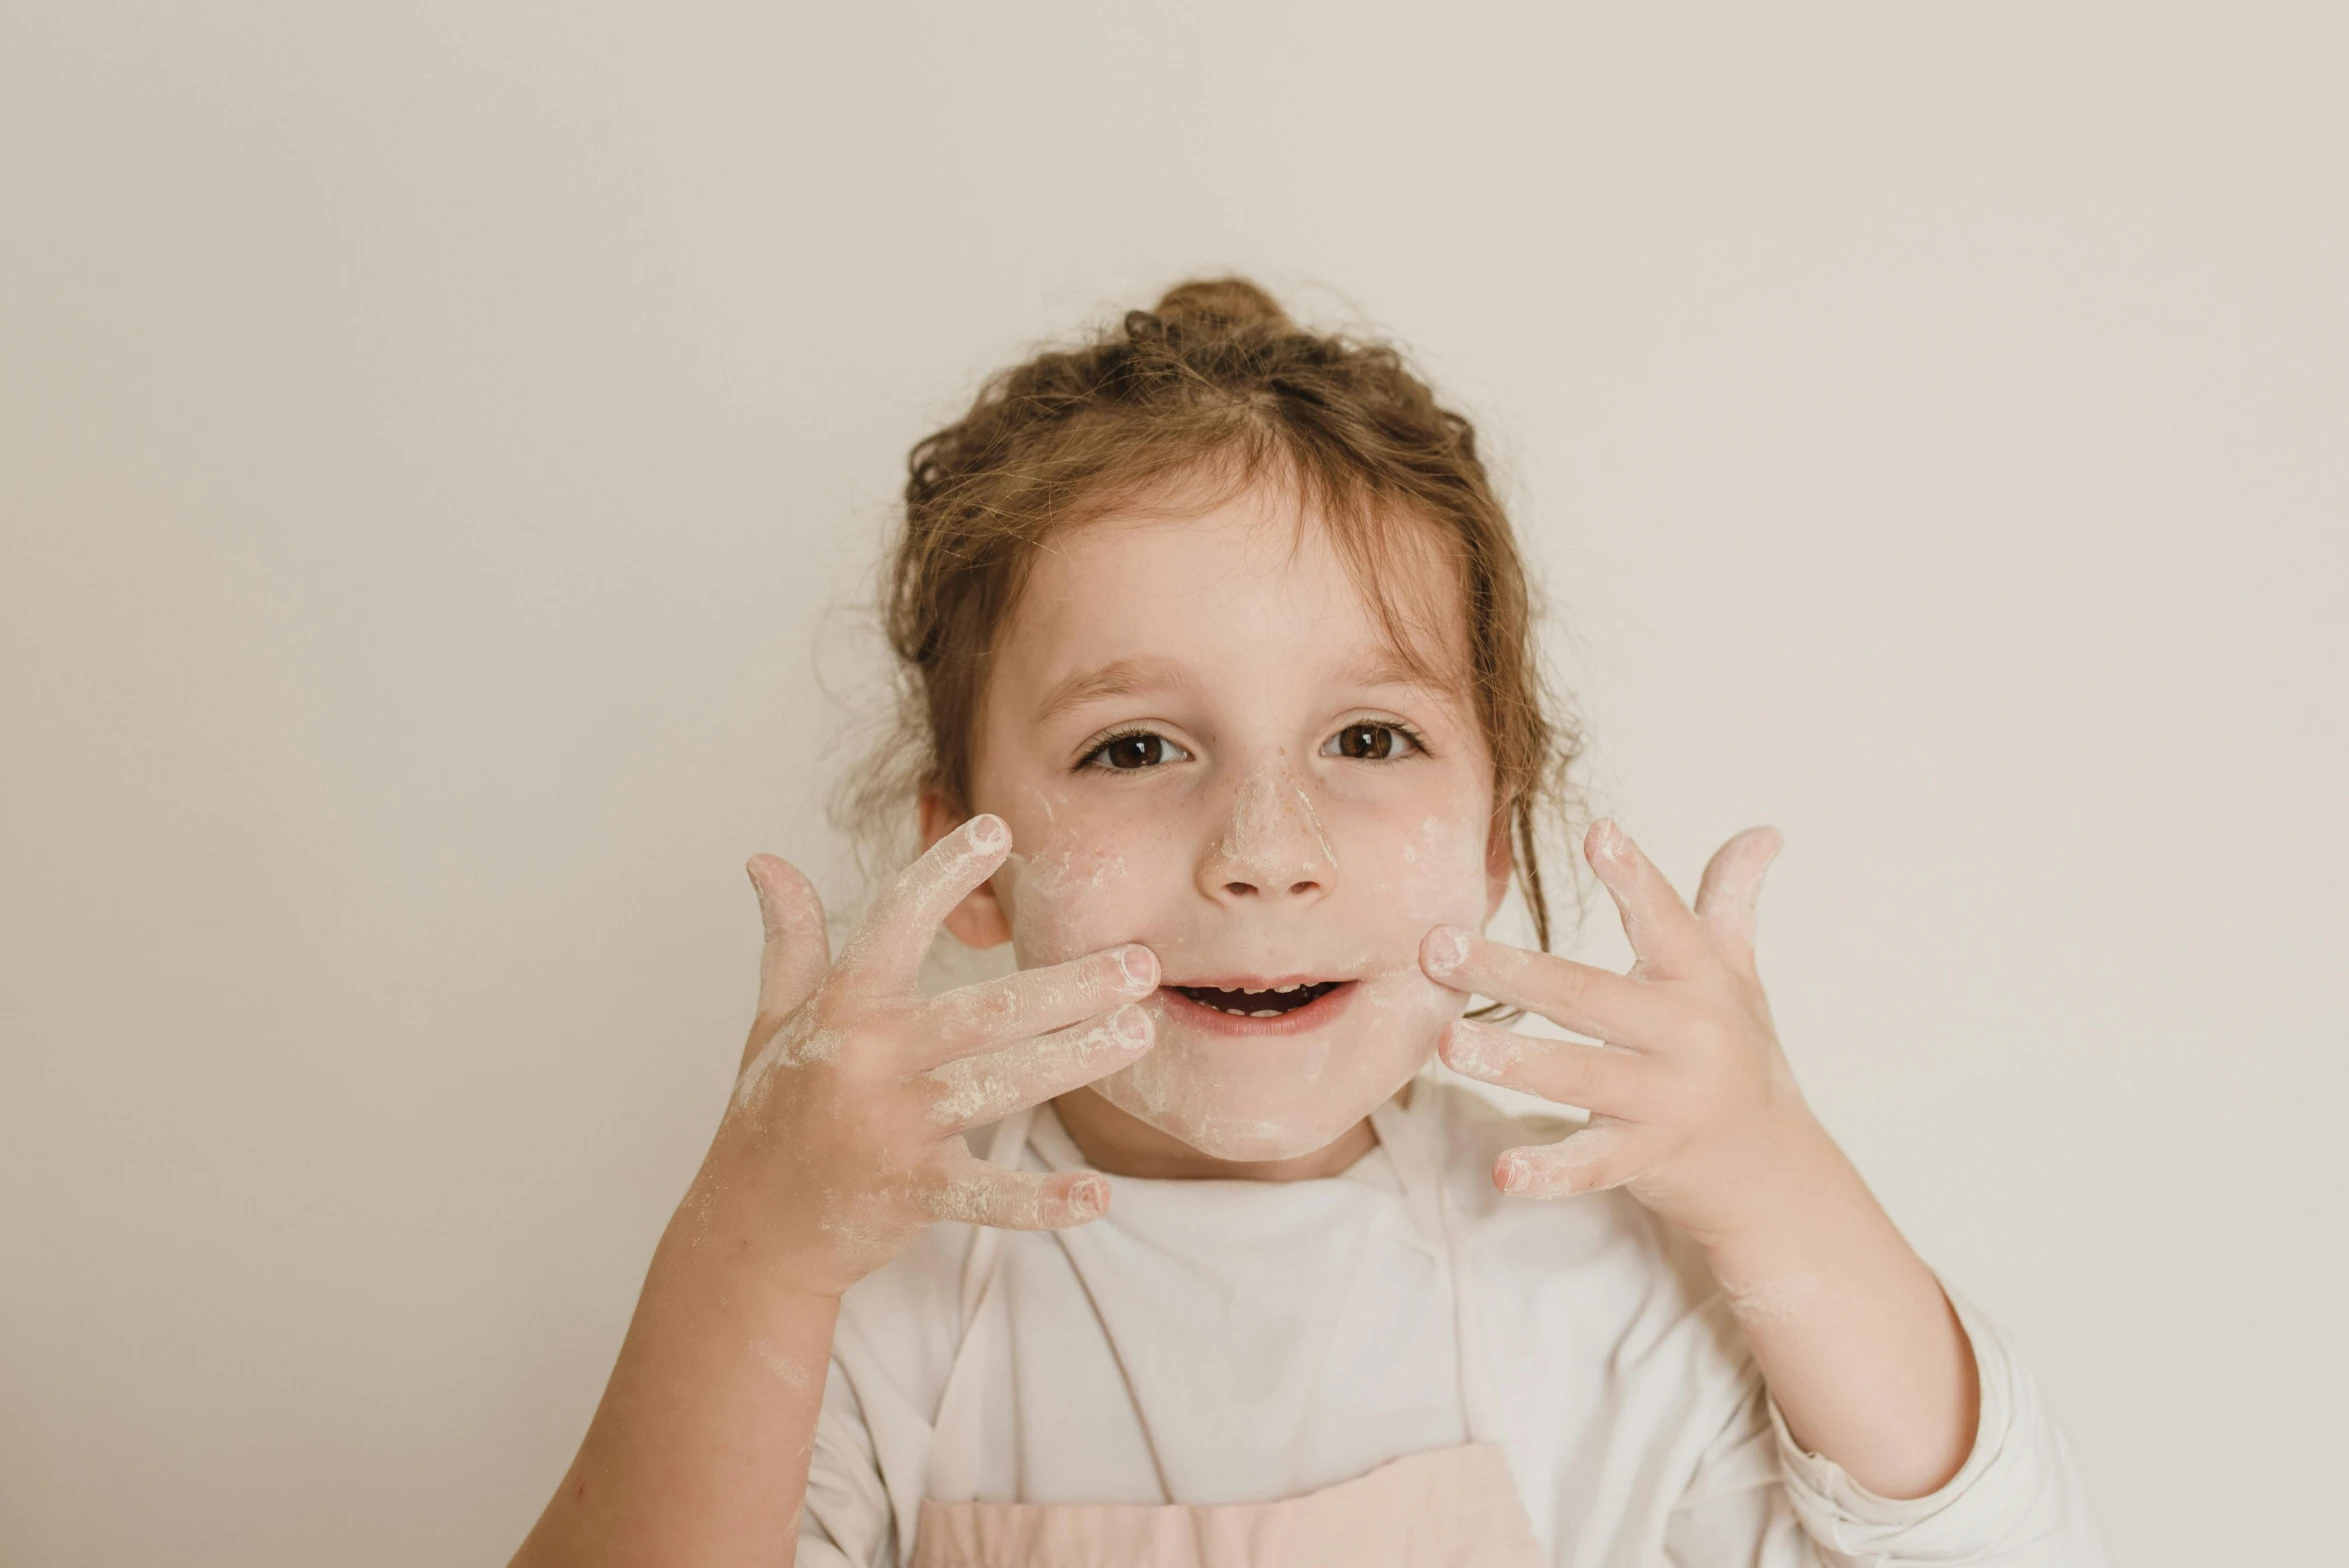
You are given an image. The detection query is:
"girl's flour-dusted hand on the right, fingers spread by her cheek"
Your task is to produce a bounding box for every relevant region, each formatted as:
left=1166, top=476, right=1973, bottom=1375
left=1419, top=822, right=1828, bottom=1244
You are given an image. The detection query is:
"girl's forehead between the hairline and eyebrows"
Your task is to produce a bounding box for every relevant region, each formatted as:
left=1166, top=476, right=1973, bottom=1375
left=996, top=486, right=1466, bottom=685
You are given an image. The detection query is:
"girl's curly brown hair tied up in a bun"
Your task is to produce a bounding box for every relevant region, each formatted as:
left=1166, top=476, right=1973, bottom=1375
left=839, top=277, right=1581, bottom=948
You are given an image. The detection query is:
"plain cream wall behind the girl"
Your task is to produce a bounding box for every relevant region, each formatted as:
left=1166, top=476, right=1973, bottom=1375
left=0, top=0, right=2349, bottom=1566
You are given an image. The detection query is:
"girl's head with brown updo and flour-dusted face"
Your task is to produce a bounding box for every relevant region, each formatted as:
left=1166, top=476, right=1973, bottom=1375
left=862, top=279, right=1571, bottom=1160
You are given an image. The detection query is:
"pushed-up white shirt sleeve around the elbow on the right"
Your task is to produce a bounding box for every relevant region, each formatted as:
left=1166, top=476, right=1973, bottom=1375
left=1665, top=1291, right=2105, bottom=1568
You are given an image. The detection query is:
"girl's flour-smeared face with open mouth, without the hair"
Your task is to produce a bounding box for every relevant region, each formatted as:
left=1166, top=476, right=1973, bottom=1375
left=949, top=491, right=1510, bottom=1162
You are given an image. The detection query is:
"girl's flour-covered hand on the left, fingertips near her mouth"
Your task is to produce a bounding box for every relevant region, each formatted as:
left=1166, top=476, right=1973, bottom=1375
left=709, top=817, right=1158, bottom=1296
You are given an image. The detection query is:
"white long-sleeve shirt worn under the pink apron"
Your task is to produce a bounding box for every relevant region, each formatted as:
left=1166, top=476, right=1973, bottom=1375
left=799, top=1077, right=2105, bottom=1568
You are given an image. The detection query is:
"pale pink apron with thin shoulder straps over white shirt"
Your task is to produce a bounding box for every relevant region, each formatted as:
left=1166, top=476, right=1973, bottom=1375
left=914, top=1106, right=1543, bottom=1568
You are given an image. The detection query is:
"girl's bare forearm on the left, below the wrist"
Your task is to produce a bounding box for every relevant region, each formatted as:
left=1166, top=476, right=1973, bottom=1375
left=514, top=1174, right=839, bottom=1568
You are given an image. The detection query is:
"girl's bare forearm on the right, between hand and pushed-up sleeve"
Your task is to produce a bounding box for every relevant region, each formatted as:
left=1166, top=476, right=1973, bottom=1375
left=1708, top=1131, right=1980, bottom=1498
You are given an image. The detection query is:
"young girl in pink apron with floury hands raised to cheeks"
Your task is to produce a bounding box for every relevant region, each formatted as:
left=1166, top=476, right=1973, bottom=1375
left=517, top=279, right=2102, bottom=1568
